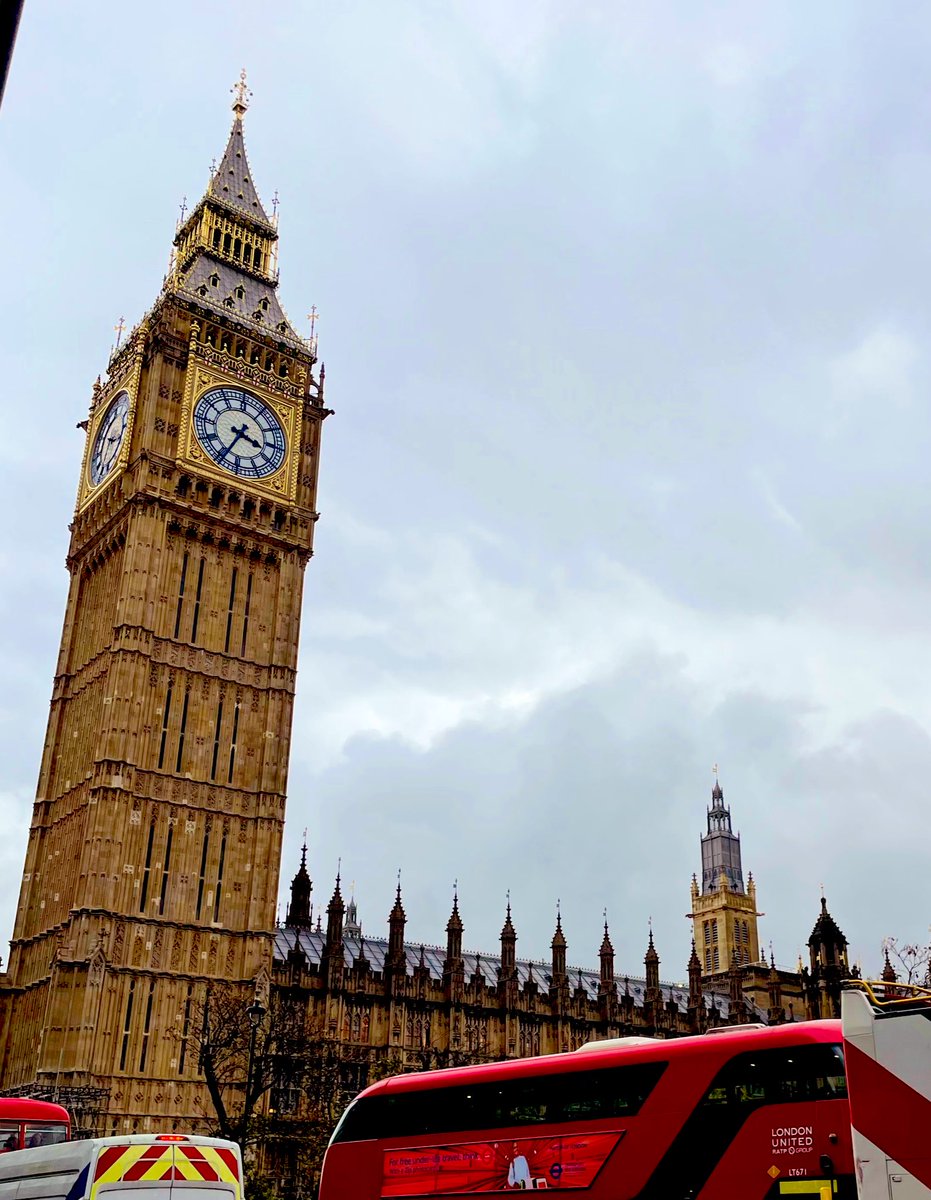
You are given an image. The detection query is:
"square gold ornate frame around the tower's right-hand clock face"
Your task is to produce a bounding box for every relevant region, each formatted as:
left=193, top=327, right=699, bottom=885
left=178, top=362, right=300, bottom=503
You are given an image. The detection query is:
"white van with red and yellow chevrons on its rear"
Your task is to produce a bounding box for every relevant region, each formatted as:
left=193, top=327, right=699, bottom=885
left=0, top=1133, right=242, bottom=1200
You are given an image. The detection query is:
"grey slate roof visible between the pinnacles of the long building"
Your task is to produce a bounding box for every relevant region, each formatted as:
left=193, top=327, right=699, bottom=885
left=275, top=925, right=748, bottom=1020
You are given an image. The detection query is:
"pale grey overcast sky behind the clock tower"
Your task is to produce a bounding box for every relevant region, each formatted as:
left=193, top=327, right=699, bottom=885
left=0, top=0, right=931, bottom=979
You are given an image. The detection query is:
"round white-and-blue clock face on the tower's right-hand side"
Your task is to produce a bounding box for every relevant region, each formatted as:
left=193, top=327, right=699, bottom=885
left=194, top=388, right=287, bottom=479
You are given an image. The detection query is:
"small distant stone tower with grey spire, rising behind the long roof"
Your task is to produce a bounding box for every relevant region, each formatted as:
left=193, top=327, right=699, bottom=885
left=690, top=780, right=761, bottom=978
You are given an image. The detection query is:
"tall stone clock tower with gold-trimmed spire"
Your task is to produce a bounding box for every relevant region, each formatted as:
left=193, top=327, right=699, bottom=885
left=0, top=78, right=328, bottom=1133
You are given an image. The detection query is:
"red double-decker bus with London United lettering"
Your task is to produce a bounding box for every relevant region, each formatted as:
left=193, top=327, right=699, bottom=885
left=320, top=1021, right=857, bottom=1200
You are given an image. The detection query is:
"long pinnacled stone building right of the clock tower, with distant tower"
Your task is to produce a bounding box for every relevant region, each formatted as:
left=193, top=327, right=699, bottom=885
left=260, top=782, right=846, bottom=1108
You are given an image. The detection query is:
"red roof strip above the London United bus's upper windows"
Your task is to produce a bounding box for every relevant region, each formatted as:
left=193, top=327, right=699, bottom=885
left=359, top=1020, right=842, bottom=1099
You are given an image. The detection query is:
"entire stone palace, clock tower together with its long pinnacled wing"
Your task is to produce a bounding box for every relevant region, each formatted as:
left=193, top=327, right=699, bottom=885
left=0, top=82, right=847, bottom=1134
